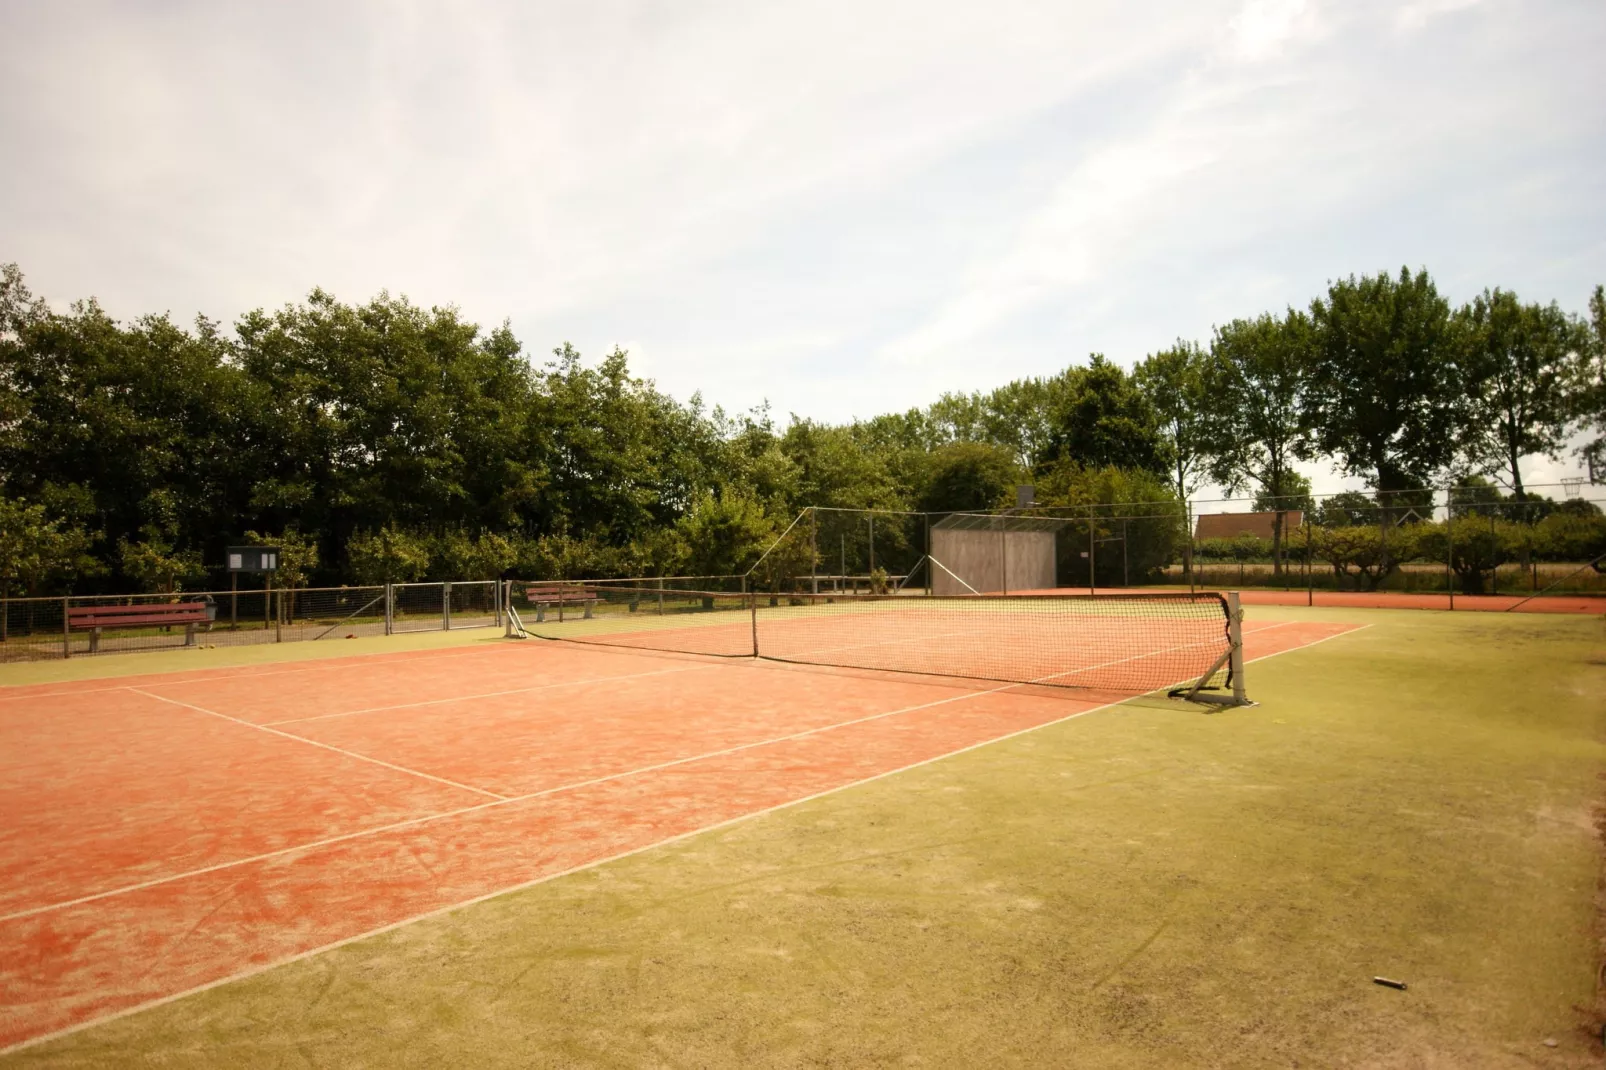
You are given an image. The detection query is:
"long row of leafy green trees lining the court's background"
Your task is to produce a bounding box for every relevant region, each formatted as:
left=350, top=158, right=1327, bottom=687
left=0, top=258, right=1606, bottom=598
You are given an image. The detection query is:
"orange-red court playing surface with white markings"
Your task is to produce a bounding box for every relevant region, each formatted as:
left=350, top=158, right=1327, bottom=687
left=0, top=622, right=1354, bottom=1052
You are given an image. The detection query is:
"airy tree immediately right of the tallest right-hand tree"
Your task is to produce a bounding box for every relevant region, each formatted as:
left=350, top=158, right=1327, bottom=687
left=1455, top=288, right=1582, bottom=501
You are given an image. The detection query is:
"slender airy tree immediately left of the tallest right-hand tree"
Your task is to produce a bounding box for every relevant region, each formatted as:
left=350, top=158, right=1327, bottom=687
left=1209, top=308, right=1314, bottom=574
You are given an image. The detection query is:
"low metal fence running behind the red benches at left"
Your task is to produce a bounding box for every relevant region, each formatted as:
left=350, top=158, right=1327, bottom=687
left=0, top=580, right=506, bottom=662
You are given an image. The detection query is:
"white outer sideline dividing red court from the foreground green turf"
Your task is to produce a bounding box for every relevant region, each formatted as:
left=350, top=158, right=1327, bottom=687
left=0, top=622, right=1372, bottom=1056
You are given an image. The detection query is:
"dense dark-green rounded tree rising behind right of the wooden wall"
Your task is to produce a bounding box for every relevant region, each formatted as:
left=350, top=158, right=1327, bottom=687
left=1037, top=353, right=1169, bottom=476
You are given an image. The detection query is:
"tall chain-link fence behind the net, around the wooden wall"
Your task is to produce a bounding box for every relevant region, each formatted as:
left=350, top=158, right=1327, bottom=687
left=745, top=485, right=1606, bottom=609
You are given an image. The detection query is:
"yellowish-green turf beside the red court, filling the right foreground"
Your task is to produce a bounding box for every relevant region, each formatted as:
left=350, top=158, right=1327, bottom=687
left=0, top=609, right=1606, bottom=1067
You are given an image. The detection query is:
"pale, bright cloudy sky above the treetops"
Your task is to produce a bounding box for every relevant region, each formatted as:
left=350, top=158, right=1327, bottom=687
left=0, top=0, right=1606, bottom=490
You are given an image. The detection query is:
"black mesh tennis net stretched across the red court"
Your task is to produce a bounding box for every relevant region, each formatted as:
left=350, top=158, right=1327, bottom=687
left=514, top=585, right=1235, bottom=694
